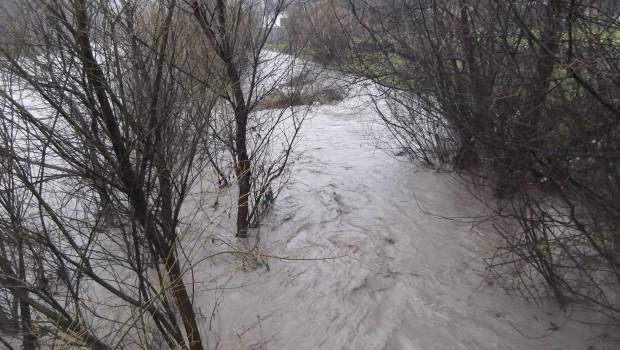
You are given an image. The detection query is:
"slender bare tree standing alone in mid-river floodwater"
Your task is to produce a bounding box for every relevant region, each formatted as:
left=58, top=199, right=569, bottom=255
left=189, top=0, right=307, bottom=238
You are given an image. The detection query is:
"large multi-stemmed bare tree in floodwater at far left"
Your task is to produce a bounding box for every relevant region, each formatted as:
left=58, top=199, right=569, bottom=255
left=0, top=0, right=214, bottom=349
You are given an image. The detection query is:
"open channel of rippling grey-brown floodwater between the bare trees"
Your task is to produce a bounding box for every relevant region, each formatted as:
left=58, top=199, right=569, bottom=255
left=185, top=91, right=618, bottom=350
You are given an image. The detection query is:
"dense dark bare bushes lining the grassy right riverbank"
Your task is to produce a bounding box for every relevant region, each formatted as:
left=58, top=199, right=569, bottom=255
left=294, top=0, right=620, bottom=317
